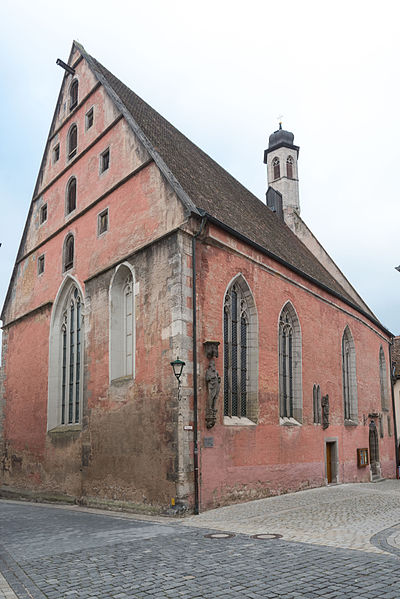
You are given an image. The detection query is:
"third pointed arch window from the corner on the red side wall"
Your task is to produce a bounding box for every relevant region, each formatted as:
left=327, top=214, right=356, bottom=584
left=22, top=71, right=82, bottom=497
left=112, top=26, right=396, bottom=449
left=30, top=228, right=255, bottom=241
left=342, top=326, right=358, bottom=424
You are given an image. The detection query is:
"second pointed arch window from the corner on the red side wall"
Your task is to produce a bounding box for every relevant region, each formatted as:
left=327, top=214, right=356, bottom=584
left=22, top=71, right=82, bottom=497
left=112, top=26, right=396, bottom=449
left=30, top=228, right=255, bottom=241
left=279, top=302, right=303, bottom=424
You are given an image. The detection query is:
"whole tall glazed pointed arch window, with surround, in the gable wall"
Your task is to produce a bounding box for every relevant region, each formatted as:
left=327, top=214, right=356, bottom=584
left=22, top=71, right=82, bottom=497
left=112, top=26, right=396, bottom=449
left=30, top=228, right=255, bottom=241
left=47, top=277, right=84, bottom=430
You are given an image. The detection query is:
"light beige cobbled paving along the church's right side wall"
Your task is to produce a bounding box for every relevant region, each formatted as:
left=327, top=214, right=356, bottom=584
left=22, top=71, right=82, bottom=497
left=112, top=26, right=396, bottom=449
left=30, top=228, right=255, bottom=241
left=183, top=480, right=400, bottom=556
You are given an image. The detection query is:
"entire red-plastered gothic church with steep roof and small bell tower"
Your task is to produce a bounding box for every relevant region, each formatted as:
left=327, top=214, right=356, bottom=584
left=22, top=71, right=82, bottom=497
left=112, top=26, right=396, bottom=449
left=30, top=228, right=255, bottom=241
left=0, top=42, right=396, bottom=512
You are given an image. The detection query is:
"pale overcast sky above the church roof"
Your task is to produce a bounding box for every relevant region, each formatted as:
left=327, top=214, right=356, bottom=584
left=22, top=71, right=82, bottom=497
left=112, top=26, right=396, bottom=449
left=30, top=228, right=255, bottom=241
left=0, top=0, right=400, bottom=334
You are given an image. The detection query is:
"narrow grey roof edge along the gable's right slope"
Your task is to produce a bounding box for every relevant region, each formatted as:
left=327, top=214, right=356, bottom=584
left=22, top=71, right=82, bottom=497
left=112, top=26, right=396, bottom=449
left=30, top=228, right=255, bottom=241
left=75, top=42, right=200, bottom=220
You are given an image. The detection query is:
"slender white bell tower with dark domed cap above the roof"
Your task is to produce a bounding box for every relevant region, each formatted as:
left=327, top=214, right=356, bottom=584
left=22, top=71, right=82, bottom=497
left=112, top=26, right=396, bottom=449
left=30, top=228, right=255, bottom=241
left=264, top=123, right=300, bottom=221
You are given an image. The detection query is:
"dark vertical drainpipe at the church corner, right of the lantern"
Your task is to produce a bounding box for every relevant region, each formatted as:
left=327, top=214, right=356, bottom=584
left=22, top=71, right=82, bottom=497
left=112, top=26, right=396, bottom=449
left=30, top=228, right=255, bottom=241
left=192, top=216, right=207, bottom=514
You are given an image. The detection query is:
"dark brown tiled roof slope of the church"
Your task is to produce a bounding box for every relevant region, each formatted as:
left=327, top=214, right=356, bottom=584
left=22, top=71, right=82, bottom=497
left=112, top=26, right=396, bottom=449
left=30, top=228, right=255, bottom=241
left=84, top=47, right=371, bottom=316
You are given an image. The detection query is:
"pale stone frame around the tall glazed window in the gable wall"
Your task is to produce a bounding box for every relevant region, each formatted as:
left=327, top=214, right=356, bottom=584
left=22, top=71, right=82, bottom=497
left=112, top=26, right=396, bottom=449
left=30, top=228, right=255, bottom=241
left=47, top=274, right=85, bottom=432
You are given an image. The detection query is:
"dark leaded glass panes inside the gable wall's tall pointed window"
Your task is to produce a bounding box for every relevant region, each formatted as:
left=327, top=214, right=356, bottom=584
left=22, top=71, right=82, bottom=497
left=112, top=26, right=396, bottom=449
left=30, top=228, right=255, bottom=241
left=61, top=287, right=82, bottom=424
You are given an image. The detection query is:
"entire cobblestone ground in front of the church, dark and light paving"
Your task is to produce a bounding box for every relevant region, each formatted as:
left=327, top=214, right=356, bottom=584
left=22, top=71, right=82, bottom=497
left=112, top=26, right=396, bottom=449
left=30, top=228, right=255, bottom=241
left=0, top=481, right=400, bottom=599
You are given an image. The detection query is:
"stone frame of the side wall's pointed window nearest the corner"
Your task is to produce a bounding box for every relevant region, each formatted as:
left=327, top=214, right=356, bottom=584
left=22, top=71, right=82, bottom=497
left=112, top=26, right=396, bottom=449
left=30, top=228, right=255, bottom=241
left=222, top=273, right=259, bottom=426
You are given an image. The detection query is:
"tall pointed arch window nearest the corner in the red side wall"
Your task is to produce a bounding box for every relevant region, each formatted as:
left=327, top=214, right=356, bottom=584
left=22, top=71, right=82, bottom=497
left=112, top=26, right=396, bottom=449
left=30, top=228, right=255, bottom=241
left=224, top=275, right=258, bottom=422
